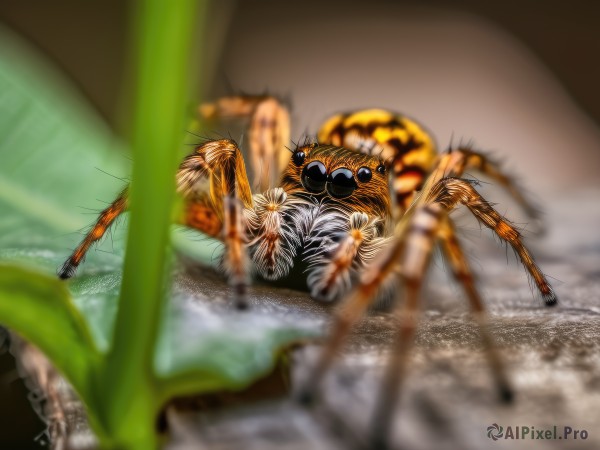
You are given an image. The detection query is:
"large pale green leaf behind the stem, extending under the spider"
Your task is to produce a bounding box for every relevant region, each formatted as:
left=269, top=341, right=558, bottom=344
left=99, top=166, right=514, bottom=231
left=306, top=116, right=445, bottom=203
left=0, top=19, right=322, bottom=406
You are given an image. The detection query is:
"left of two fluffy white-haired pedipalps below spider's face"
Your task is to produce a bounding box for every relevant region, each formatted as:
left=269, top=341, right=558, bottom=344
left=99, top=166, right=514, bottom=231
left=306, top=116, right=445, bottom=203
left=245, top=188, right=300, bottom=280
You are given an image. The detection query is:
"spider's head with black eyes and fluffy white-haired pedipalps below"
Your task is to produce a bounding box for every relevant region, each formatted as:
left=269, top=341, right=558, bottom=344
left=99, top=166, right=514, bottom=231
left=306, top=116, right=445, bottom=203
left=246, top=143, right=391, bottom=301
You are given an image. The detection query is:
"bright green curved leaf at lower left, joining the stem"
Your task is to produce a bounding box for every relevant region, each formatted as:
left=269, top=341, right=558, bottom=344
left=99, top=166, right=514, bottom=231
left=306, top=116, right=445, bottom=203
left=0, top=265, right=100, bottom=403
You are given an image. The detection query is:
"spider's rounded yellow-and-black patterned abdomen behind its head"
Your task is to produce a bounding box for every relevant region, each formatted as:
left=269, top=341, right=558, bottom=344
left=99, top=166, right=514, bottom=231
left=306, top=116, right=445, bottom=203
left=318, top=109, right=437, bottom=210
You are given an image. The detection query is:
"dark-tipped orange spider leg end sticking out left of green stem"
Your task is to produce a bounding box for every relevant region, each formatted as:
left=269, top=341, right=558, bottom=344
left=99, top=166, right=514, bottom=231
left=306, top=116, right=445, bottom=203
left=58, top=188, right=128, bottom=280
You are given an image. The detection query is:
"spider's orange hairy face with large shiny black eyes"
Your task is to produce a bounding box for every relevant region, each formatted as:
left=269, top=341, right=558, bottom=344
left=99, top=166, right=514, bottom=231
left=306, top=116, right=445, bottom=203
left=281, top=144, right=390, bottom=220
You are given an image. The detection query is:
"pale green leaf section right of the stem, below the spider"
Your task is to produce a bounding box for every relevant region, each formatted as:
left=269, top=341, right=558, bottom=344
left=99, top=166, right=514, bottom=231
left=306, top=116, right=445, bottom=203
left=155, top=271, right=327, bottom=398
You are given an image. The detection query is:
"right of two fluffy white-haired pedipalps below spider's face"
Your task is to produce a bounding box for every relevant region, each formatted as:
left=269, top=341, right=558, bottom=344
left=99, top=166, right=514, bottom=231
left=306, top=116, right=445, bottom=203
left=304, top=211, right=388, bottom=301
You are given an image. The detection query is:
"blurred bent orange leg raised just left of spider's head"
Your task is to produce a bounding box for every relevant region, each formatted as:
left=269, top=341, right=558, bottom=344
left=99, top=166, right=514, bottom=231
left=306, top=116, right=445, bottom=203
left=199, top=95, right=290, bottom=192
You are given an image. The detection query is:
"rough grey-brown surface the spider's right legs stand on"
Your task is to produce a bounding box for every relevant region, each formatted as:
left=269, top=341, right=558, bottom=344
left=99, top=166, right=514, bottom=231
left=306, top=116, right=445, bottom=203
left=14, top=191, right=600, bottom=449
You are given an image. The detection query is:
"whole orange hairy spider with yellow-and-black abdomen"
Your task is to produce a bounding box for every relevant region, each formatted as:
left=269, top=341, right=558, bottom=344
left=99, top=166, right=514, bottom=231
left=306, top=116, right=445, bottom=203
left=59, top=96, right=556, bottom=442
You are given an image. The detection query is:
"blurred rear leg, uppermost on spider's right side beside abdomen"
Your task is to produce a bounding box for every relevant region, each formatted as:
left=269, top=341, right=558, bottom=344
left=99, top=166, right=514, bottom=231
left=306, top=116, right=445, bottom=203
left=440, top=147, right=541, bottom=227
